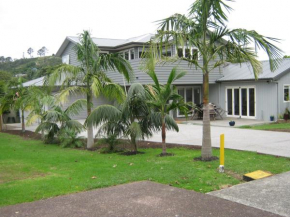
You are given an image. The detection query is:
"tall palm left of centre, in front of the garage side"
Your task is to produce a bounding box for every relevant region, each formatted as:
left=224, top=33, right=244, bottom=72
left=49, top=31, right=133, bottom=149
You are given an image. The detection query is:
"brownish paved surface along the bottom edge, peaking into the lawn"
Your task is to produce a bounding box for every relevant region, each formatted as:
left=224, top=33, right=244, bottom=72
left=0, top=181, right=278, bottom=217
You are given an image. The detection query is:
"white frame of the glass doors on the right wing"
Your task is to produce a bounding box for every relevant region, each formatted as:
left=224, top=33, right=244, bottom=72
left=225, top=86, right=257, bottom=119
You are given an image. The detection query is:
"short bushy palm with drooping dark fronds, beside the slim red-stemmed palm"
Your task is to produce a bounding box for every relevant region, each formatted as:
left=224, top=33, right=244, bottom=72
left=86, top=83, right=157, bottom=153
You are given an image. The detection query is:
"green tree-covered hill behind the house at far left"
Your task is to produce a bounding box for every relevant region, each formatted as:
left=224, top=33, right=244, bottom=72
left=0, top=56, right=61, bottom=80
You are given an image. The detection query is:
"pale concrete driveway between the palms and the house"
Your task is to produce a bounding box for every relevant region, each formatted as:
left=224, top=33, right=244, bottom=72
left=148, top=124, right=290, bottom=157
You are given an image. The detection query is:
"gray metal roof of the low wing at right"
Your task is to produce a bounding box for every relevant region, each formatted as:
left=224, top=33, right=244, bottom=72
left=217, top=59, right=290, bottom=82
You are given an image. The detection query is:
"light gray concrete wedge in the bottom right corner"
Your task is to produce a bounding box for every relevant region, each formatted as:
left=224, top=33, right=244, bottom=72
left=208, top=172, right=290, bottom=216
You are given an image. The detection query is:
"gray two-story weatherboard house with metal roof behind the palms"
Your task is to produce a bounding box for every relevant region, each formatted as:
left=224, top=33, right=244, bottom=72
left=25, top=34, right=290, bottom=121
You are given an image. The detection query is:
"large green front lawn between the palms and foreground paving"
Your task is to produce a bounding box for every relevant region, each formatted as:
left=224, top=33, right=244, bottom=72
left=0, top=133, right=290, bottom=206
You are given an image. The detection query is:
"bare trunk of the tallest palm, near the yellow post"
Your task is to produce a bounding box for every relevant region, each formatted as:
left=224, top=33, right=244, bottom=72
left=201, top=72, right=212, bottom=160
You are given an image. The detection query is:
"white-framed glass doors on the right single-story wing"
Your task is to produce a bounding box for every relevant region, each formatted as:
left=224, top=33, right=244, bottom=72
left=226, top=87, right=256, bottom=118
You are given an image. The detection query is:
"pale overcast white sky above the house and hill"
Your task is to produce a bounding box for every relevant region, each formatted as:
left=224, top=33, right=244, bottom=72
left=0, top=0, right=290, bottom=60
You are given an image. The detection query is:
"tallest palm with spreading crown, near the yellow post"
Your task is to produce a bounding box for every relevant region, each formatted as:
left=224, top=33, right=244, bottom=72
left=152, top=0, right=281, bottom=160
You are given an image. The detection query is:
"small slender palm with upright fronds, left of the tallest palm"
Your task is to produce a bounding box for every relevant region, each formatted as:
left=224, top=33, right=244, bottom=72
left=147, top=68, right=188, bottom=156
